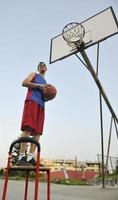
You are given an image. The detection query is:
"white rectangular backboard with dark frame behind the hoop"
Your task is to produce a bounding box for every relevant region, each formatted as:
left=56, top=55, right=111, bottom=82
left=50, top=7, right=118, bottom=64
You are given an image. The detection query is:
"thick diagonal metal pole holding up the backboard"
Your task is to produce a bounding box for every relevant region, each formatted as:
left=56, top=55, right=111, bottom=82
left=80, top=49, right=118, bottom=123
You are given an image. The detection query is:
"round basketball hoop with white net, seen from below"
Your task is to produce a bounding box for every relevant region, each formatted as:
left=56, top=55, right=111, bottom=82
left=62, top=22, right=85, bottom=48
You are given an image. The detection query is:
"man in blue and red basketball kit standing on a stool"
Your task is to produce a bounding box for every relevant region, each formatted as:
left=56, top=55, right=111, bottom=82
left=18, top=62, right=49, bottom=165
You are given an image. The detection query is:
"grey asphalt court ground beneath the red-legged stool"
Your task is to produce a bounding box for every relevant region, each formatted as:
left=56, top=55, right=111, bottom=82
left=0, top=180, right=118, bottom=200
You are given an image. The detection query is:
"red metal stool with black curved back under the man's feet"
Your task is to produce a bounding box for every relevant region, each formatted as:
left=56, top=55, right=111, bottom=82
left=2, top=137, right=50, bottom=200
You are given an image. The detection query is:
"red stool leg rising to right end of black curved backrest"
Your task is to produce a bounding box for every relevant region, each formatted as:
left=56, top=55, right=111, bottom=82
left=34, top=152, right=40, bottom=200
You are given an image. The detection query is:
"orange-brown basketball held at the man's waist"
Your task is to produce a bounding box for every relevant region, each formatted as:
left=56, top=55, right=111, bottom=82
left=43, top=85, right=57, bottom=101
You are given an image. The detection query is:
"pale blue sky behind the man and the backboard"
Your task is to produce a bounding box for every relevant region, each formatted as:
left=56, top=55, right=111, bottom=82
left=0, top=0, right=118, bottom=166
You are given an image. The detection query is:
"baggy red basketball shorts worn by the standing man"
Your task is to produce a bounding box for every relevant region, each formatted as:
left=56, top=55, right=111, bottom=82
left=21, top=100, right=45, bottom=135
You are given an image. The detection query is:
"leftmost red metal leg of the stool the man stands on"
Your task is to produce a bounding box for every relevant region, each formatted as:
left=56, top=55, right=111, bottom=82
left=2, top=154, right=11, bottom=200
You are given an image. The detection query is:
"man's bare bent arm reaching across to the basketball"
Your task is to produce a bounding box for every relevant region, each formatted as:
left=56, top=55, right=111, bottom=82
left=22, top=72, right=46, bottom=90
